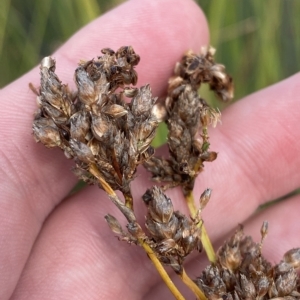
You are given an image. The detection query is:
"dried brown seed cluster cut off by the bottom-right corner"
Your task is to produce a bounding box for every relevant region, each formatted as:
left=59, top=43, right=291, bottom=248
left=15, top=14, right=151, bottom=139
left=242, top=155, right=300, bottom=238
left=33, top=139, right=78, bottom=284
left=196, top=222, right=300, bottom=300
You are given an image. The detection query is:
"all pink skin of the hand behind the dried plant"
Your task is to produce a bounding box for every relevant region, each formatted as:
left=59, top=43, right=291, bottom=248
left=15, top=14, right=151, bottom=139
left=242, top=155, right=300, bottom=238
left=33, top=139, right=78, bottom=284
left=0, top=0, right=300, bottom=300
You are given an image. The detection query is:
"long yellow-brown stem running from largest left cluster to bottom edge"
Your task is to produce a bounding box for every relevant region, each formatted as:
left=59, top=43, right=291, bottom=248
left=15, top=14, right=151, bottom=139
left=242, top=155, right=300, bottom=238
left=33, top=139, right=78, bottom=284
left=89, top=164, right=184, bottom=300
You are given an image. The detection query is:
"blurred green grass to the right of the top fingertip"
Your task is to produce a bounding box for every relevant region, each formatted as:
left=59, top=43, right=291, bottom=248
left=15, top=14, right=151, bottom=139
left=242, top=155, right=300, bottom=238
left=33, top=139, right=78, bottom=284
left=198, top=0, right=300, bottom=103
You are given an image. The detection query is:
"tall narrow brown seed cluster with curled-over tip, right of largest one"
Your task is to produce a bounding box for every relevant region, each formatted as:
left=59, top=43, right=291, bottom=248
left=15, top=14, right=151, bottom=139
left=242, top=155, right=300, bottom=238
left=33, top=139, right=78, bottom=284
left=144, top=47, right=233, bottom=191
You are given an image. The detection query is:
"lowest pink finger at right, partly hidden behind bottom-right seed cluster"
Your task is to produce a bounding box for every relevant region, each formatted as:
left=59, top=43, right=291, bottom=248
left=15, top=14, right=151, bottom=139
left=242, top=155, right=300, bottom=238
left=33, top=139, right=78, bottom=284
left=148, top=195, right=300, bottom=300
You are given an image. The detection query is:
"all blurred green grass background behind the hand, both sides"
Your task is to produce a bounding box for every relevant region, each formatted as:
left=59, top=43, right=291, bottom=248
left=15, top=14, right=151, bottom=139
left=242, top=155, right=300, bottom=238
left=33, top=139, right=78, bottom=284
left=0, top=0, right=300, bottom=200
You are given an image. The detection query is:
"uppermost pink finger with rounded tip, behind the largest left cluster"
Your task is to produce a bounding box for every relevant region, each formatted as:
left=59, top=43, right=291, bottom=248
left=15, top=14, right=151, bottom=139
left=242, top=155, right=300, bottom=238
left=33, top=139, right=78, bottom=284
left=0, top=0, right=208, bottom=299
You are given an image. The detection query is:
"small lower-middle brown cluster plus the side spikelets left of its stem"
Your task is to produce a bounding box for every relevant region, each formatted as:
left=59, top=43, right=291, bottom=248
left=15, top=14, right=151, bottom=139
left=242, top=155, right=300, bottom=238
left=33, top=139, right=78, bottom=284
left=105, top=186, right=202, bottom=274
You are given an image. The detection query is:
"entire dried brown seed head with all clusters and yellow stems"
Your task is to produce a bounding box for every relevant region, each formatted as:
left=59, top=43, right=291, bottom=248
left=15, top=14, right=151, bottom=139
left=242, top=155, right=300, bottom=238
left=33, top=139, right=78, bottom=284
left=33, top=46, right=300, bottom=300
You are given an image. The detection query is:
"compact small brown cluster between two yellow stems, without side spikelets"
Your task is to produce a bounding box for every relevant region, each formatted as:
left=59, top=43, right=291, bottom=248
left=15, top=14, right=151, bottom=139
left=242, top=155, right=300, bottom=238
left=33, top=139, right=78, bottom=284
left=143, top=186, right=202, bottom=273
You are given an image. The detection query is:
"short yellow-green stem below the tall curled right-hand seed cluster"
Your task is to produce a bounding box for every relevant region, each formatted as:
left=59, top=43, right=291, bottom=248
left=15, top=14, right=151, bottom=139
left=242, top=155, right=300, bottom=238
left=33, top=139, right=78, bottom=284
left=185, top=191, right=216, bottom=263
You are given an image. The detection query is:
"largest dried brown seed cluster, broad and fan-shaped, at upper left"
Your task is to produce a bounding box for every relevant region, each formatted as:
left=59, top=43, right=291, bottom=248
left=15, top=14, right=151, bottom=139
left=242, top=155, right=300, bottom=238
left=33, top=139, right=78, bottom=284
left=33, top=47, right=158, bottom=194
